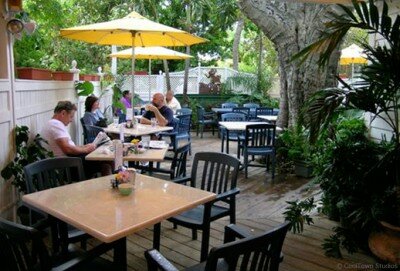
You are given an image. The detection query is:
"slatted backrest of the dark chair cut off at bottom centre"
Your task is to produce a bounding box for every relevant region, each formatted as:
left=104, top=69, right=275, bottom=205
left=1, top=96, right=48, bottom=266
left=204, top=222, right=289, bottom=271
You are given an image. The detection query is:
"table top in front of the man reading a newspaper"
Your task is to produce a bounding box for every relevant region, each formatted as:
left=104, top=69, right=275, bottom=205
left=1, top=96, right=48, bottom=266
left=85, top=143, right=168, bottom=162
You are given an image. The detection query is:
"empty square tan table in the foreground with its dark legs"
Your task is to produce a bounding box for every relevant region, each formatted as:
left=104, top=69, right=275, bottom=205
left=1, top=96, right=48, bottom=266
left=22, top=174, right=216, bottom=270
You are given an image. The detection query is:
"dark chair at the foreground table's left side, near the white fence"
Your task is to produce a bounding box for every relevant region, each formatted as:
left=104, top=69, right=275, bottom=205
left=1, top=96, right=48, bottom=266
left=24, top=157, right=90, bottom=253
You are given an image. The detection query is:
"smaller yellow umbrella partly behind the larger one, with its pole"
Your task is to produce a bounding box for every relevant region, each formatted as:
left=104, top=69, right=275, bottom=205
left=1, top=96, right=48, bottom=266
left=109, top=46, right=192, bottom=101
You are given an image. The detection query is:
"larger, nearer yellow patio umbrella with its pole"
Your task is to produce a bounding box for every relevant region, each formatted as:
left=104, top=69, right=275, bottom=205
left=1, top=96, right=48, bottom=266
left=60, top=12, right=207, bottom=107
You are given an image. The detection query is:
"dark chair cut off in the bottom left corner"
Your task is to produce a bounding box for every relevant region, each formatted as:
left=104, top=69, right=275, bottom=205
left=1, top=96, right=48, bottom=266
left=0, top=217, right=115, bottom=271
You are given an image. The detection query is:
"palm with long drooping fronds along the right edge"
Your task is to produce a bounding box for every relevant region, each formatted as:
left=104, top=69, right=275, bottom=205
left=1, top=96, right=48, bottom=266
left=296, top=0, right=400, bottom=225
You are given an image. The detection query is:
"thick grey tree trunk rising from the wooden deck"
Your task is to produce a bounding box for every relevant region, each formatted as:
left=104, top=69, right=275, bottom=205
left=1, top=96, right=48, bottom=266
left=239, top=0, right=339, bottom=127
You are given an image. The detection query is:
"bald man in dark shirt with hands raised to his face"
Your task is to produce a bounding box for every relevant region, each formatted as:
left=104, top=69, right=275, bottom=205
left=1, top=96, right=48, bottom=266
left=140, top=93, right=174, bottom=127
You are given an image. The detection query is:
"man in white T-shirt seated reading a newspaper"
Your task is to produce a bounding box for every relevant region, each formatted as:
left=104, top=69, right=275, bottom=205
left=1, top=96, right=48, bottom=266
left=40, top=101, right=111, bottom=177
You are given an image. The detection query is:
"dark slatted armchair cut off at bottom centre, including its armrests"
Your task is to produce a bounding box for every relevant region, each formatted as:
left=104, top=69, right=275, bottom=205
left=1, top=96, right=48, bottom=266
left=145, top=222, right=290, bottom=271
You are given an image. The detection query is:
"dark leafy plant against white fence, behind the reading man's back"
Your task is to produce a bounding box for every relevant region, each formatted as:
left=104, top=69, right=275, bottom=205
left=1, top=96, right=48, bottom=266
left=1, top=126, right=53, bottom=193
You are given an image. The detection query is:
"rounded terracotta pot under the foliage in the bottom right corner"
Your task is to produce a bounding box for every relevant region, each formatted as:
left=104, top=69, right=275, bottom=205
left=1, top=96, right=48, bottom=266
left=368, top=222, right=400, bottom=264
